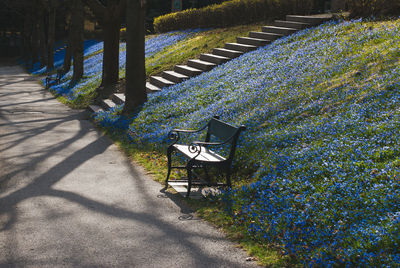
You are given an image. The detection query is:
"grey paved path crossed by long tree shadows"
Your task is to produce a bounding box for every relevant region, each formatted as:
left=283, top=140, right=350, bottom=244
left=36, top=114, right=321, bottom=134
left=0, top=63, right=254, bottom=267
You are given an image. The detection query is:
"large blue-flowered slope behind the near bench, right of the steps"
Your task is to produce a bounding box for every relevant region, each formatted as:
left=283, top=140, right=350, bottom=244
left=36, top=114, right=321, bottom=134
left=95, top=19, right=400, bottom=266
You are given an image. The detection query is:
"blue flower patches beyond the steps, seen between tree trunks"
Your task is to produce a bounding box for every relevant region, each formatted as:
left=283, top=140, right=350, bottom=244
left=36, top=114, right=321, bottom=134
left=43, top=29, right=198, bottom=101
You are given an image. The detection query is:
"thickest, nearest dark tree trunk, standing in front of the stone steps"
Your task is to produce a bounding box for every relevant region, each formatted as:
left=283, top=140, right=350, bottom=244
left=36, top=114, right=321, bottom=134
left=123, top=0, right=147, bottom=114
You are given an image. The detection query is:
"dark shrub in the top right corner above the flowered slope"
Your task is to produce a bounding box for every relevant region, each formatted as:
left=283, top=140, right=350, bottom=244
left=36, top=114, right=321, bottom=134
left=347, top=0, right=400, bottom=17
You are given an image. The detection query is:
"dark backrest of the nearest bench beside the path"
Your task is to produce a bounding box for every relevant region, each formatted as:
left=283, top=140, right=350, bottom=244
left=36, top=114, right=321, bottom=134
left=205, top=116, right=246, bottom=159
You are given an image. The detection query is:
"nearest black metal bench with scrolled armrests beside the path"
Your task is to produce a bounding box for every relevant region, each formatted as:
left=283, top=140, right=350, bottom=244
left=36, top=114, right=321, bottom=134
left=165, top=116, right=246, bottom=197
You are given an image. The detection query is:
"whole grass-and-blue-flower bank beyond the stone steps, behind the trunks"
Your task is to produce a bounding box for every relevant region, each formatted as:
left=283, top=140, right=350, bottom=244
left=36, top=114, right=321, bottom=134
left=39, top=25, right=261, bottom=108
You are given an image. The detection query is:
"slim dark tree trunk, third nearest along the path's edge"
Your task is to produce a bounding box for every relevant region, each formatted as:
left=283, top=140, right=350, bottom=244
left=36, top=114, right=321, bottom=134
left=70, top=0, right=84, bottom=81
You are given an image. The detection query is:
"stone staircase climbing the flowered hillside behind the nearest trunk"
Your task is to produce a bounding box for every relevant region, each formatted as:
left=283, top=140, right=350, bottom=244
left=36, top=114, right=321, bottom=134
left=90, top=14, right=332, bottom=112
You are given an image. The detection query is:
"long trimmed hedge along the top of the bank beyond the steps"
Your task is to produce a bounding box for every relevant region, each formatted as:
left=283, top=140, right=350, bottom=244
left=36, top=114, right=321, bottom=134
left=154, top=0, right=315, bottom=32
